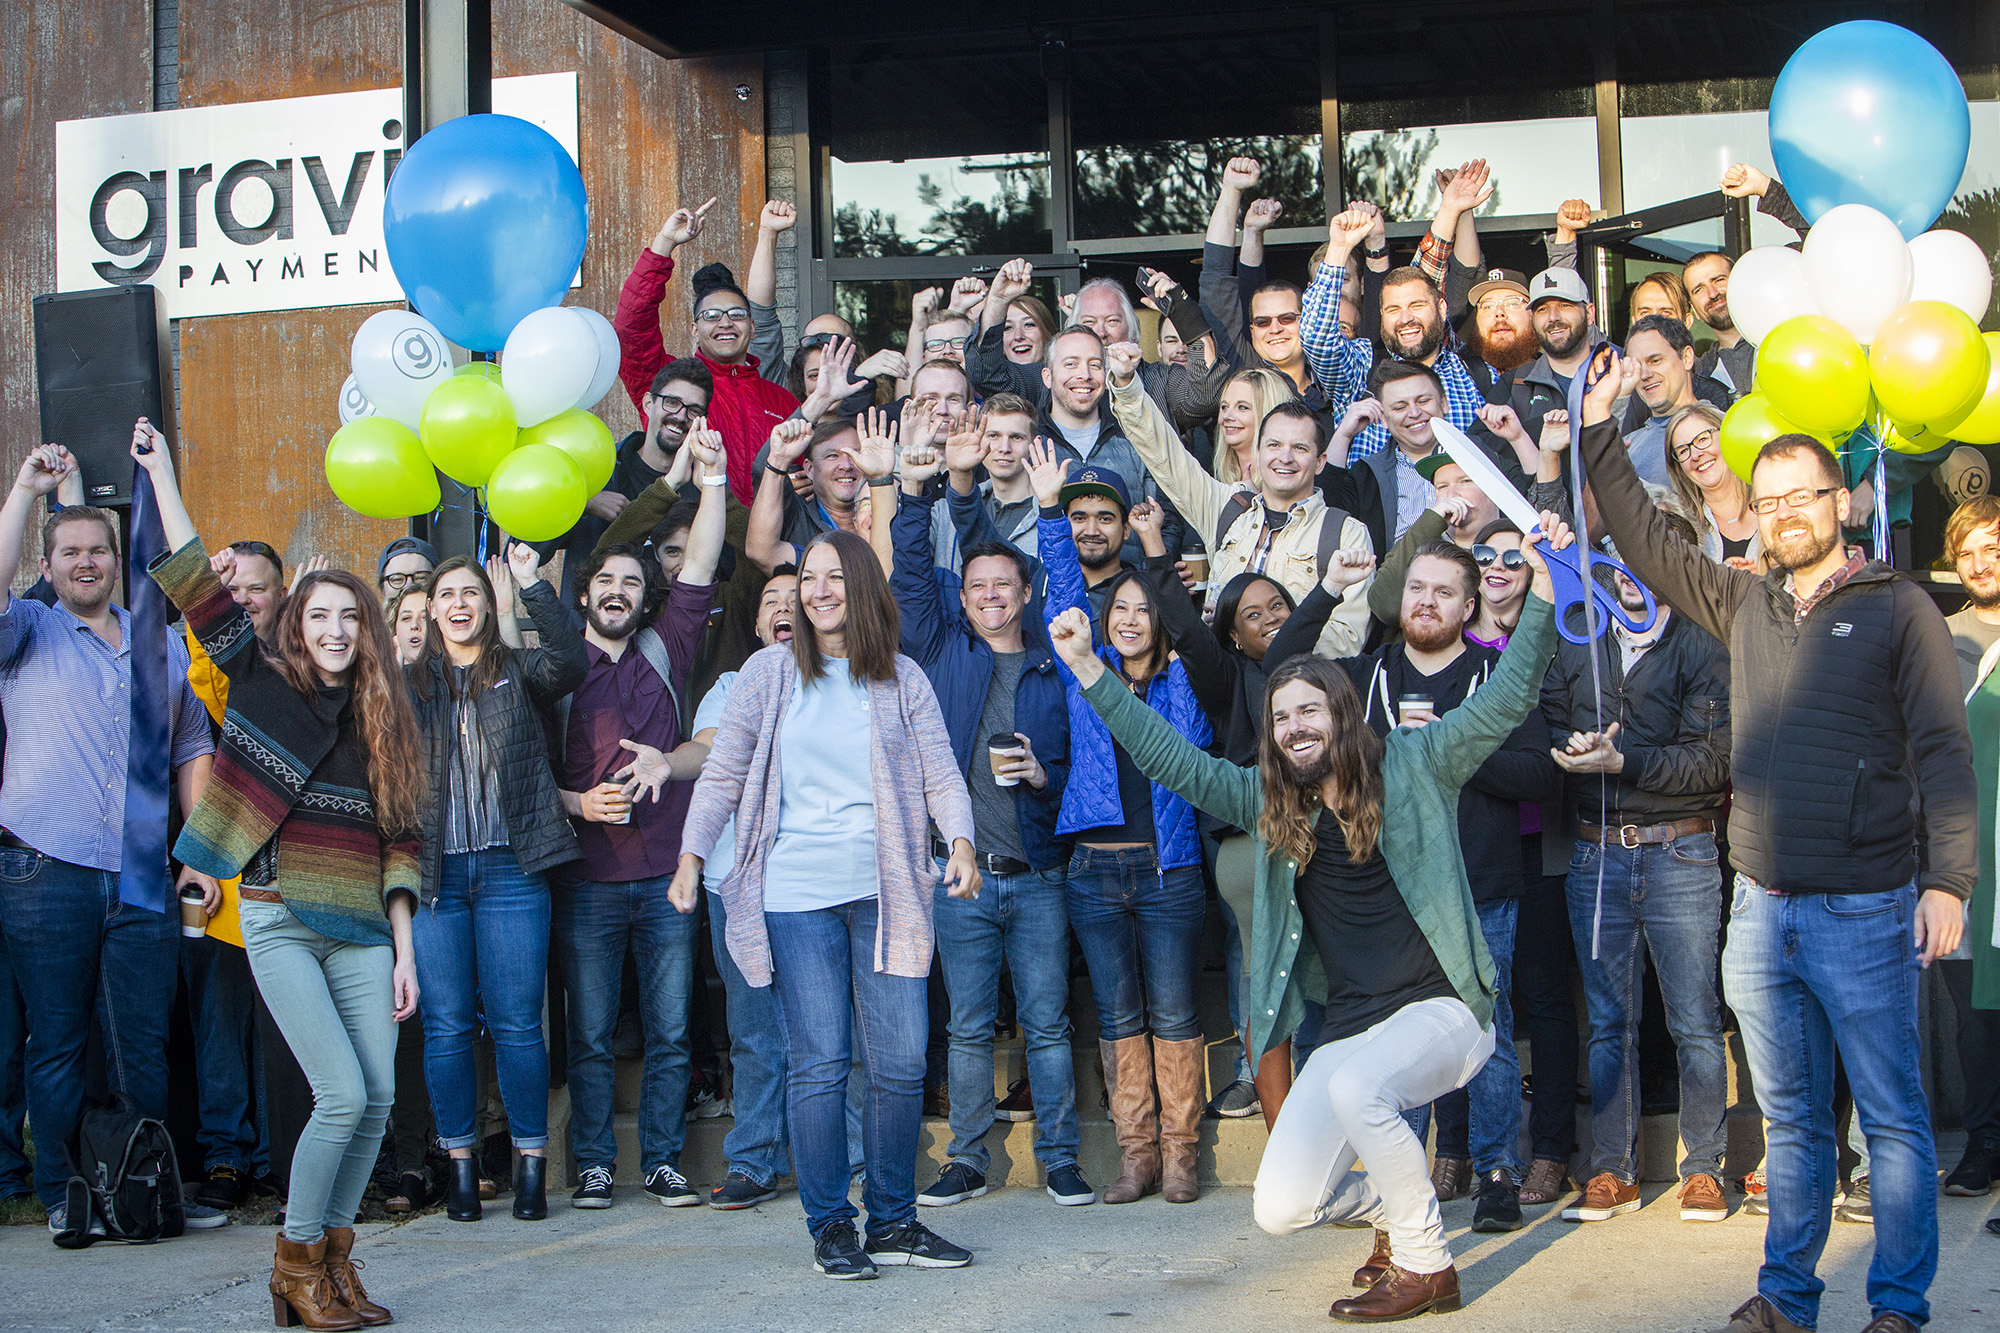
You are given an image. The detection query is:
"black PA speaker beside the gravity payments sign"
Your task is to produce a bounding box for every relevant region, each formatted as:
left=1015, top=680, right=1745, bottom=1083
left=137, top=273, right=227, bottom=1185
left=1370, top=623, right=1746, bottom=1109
left=34, top=284, right=174, bottom=504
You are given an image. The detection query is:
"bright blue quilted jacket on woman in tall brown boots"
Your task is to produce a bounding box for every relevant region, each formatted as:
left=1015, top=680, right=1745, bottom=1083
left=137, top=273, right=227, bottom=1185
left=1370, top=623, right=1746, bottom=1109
left=1036, top=508, right=1212, bottom=871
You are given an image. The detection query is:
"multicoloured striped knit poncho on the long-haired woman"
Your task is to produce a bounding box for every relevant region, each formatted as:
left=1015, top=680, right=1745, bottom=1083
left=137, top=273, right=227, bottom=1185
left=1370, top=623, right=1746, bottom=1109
left=150, top=540, right=420, bottom=945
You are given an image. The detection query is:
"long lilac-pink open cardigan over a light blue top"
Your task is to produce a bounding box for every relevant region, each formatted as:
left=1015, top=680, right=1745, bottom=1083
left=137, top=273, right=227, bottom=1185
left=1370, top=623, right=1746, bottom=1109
left=680, top=644, right=972, bottom=987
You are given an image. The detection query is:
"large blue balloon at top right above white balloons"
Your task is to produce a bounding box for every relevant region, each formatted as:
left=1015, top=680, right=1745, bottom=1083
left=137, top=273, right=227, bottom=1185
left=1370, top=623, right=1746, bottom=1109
left=1770, top=18, right=1972, bottom=240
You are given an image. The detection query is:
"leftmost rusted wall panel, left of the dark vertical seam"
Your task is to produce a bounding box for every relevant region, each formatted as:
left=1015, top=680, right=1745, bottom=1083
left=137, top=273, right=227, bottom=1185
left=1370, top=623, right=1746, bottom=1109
left=0, top=0, right=152, bottom=586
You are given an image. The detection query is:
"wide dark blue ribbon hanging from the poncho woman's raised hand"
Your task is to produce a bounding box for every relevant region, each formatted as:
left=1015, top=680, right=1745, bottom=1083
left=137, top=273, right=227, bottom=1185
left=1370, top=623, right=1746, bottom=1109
left=118, top=464, right=174, bottom=913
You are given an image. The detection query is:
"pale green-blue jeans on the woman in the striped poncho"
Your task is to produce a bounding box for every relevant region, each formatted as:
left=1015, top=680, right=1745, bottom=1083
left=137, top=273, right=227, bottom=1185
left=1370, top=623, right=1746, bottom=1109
left=242, top=903, right=396, bottom=1245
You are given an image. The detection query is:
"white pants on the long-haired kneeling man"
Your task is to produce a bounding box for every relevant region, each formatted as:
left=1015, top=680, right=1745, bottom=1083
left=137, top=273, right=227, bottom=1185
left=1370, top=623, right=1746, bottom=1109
left=1252, top=999, right=1494, bottom=1273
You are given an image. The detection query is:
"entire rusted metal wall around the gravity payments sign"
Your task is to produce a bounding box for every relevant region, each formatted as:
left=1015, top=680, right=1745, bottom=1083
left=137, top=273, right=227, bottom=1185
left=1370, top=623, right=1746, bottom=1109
left=0, top=0, right=764, bottom=588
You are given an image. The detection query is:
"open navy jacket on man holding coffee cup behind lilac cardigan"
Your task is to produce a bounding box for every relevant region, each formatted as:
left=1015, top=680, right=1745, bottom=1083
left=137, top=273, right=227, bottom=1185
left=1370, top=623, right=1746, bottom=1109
left=890, top=494, right=1070, bottom=871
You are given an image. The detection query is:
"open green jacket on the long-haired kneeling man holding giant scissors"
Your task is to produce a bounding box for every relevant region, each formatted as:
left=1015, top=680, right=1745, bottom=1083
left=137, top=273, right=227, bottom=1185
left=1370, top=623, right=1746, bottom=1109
left=1084, top=594, right=1556, bottom=1065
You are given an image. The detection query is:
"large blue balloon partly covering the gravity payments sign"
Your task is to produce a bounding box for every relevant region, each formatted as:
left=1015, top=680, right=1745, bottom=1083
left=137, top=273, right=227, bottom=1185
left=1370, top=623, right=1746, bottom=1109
left=382, top=116, right=590, bottom=352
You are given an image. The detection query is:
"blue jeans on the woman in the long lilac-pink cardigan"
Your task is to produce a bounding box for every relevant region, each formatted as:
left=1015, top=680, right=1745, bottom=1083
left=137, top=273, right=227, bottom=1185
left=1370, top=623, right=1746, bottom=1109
left=764, top=899, right=930, bottom=1235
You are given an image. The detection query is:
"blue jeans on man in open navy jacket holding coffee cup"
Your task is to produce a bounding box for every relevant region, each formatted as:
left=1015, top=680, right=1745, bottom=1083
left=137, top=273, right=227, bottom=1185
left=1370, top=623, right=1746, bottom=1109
left=932, top=861, right=1080, bottom=1175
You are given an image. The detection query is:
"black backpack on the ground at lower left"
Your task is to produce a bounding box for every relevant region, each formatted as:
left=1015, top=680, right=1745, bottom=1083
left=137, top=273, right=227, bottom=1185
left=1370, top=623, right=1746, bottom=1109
left=56, top=1093, right=188, bottom=1249
